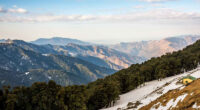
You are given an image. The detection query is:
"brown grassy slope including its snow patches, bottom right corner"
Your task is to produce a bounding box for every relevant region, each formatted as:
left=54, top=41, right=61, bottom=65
left=140, top=71, right=200, bottom=110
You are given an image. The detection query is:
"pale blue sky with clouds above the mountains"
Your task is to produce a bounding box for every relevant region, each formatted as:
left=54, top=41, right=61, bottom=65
left=0, top=0, right=200, bottom=44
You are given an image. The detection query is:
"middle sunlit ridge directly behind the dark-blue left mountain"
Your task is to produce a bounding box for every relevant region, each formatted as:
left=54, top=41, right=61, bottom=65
left=13, top=40, right=146, bottom=70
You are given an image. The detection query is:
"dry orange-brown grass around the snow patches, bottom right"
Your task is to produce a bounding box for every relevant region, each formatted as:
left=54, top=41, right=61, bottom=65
left=140, top=79, right=200, bottom=110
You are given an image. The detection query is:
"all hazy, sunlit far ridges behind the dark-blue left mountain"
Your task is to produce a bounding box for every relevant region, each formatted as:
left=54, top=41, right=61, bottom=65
left=2, top=35, right=200, bottom=70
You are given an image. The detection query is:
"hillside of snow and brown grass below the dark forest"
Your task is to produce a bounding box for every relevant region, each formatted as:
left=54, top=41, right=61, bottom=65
left=105, top=67, right=200, bottom=110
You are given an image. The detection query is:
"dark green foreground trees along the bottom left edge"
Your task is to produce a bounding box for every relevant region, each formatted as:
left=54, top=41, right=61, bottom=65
left=0, top=80, right=119, bottom=110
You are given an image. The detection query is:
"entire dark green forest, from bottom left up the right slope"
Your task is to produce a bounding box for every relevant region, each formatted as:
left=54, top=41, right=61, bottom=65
left=0, top=40, right=200, bottom=110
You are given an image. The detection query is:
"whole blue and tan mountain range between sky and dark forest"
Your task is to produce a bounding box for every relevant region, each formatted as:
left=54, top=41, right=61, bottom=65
left=0, top=36, right=199, bottom=86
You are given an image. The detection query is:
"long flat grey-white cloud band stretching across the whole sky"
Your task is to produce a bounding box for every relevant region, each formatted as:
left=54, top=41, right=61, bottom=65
left=0, top=8, right=200, bottom=22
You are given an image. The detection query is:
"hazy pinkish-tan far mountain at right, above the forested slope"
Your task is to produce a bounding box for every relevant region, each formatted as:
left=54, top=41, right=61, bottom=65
left=110, top=35, right=200, bottom=58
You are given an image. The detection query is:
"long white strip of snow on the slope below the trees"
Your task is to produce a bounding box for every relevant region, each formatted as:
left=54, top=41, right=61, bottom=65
left=102, top=67, right=200, bottom=110
